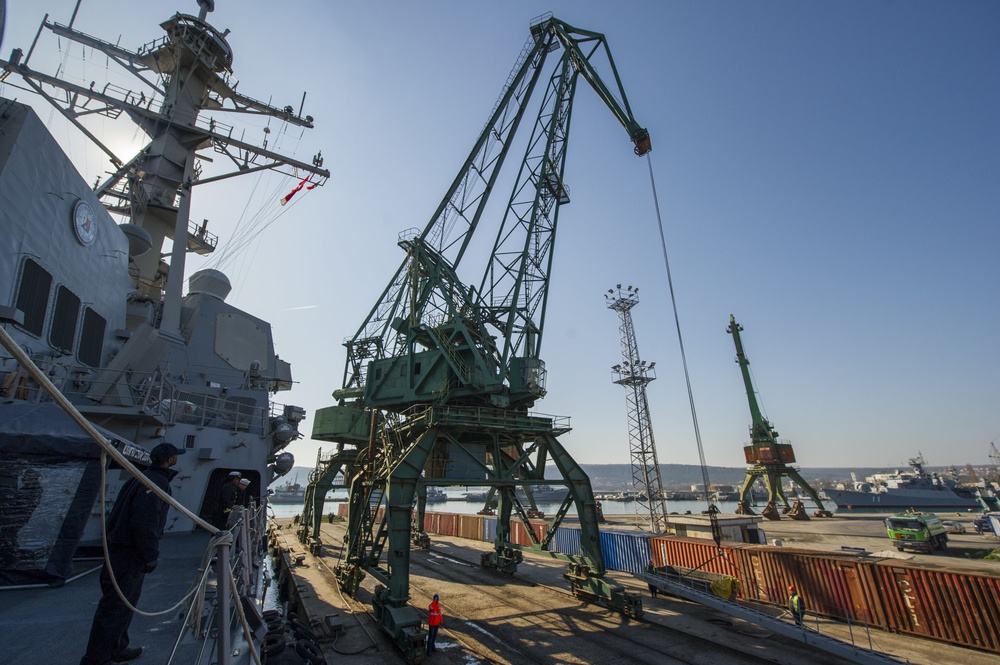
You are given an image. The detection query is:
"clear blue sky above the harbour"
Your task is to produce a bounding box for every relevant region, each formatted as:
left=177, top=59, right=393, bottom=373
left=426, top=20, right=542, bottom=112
left=0, top=0, right=1000, bottom=467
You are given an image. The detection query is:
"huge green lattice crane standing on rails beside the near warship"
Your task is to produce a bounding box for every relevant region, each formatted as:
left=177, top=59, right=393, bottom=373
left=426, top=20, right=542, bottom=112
left=299, top=15, right=650, bottom=662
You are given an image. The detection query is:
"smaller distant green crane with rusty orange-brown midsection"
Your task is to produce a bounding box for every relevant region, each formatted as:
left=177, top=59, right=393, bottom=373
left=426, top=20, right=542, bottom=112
left=726, top=314, right=831, bottom=520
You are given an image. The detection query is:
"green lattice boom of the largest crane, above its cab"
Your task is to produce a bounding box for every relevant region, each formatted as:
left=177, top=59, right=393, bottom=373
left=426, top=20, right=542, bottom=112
left=335, top=16, right=650, bottom=406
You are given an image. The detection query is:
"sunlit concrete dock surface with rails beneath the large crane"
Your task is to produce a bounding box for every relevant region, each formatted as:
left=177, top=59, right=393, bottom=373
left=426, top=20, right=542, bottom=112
left=274, top=518, right=996, bottom=665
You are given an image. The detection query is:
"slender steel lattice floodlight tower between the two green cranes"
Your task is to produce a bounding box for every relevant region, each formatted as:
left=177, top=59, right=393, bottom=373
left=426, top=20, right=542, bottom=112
left=604, top=284, right=667, bottom=533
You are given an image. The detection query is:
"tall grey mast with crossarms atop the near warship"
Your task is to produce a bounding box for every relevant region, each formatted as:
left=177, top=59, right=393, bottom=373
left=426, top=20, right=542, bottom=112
left=0, top=0, right=330, bottom=339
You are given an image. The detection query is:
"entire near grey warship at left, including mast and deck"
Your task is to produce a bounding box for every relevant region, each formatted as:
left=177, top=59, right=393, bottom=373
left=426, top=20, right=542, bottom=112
left=0, top=0, right=329, bottom=664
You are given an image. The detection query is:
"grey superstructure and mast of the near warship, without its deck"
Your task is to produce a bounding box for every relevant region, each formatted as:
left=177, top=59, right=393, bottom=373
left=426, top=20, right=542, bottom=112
left=0, top=0, right=329, bottom=662
